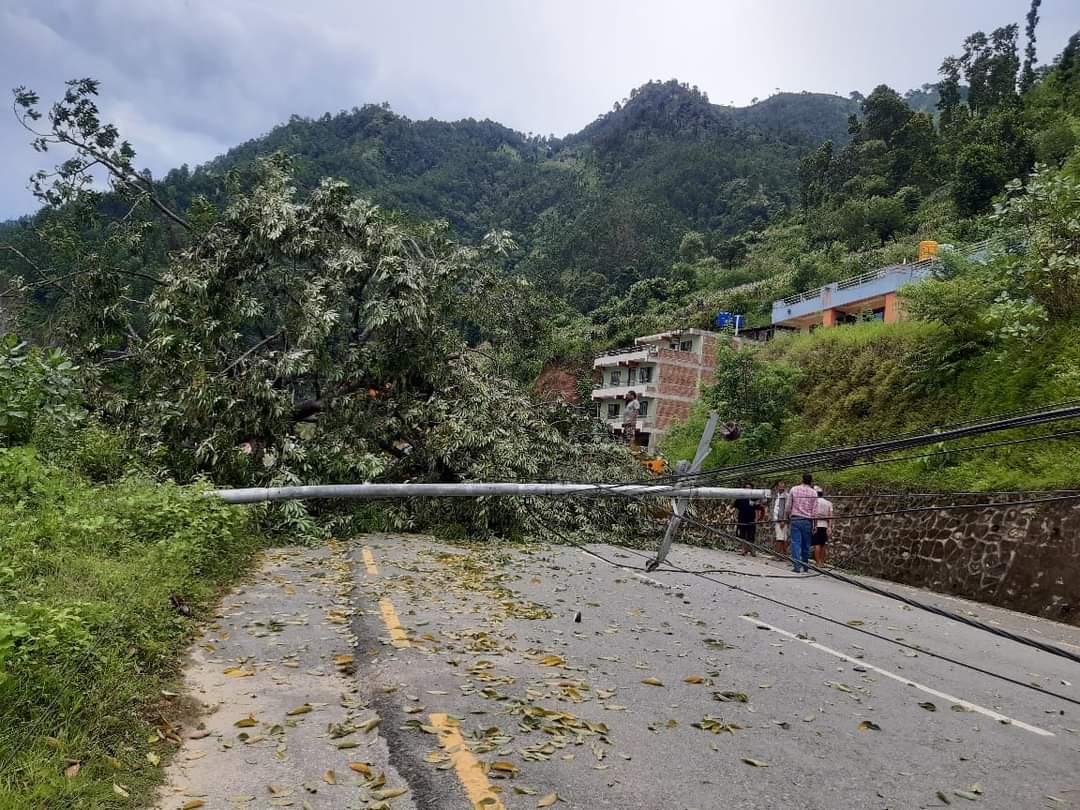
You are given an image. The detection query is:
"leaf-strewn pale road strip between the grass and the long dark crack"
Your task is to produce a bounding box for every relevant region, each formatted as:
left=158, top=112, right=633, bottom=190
left=159, top=543, right=415, bottom=810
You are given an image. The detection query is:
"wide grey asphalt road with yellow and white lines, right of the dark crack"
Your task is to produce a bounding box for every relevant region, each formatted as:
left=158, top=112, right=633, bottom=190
left=352, top=535, right=1080, bottom=810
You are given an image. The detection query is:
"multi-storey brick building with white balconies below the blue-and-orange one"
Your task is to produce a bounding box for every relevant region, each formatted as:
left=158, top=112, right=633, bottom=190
left=593, top=329, right=723, bottom=450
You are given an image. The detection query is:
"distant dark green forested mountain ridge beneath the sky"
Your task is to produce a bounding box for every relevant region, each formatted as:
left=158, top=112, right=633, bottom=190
left=150, top=81, right=858, bottom=311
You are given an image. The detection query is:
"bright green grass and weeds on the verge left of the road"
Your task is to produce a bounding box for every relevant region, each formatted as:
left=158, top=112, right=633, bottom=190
left=0, top=448, right=258, bottom=810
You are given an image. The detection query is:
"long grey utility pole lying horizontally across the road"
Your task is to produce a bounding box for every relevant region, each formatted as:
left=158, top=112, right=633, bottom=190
left=212, top=482, right=769, bottom=503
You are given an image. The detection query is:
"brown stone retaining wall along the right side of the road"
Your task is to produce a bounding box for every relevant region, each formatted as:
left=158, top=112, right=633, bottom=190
left=829, top=492, right=1080, bottom=625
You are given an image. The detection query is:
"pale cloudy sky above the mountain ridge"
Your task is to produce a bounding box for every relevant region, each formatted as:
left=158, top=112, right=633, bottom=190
left=0, top=0, right=1080, bottom=219
